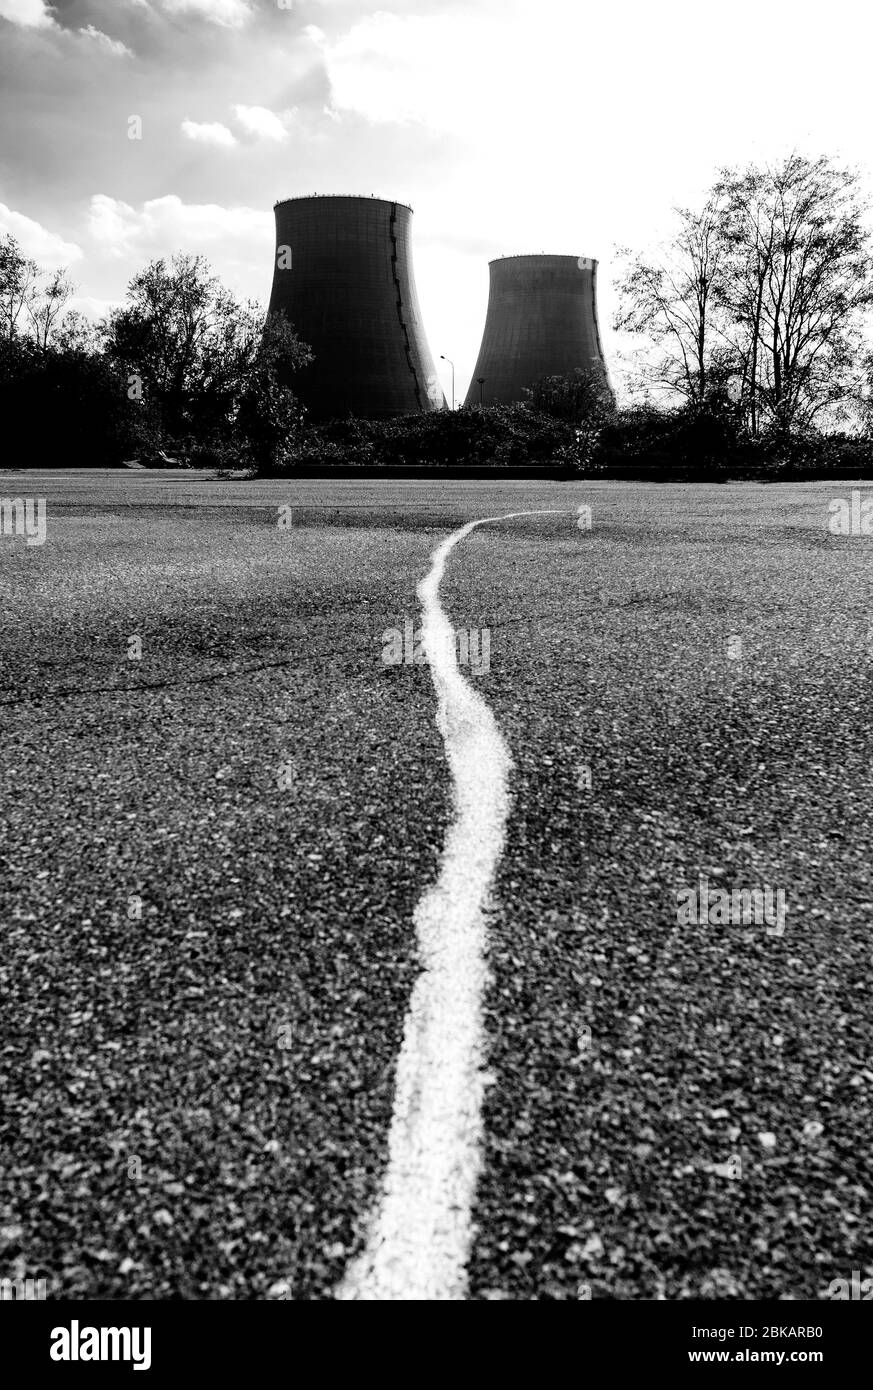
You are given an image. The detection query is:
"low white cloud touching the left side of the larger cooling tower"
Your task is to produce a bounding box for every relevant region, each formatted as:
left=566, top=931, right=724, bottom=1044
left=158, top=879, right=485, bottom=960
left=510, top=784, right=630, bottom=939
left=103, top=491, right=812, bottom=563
left=89, top=193, right=272, bottom=267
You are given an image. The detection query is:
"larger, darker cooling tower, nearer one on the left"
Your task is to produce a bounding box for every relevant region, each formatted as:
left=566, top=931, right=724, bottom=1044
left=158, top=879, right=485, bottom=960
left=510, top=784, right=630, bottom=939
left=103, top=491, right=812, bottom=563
left=270, top=196, right=445, bottom=420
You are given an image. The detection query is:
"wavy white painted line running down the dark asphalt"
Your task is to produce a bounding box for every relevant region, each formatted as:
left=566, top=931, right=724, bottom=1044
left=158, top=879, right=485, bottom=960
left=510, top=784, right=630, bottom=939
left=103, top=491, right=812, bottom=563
left=335, top=512, right=567, bottom=1302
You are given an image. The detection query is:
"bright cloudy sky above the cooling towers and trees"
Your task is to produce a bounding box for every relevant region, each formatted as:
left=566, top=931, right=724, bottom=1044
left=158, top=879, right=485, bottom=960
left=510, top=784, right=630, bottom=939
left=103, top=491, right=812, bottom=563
left=0, top=0, right=873, bottom=395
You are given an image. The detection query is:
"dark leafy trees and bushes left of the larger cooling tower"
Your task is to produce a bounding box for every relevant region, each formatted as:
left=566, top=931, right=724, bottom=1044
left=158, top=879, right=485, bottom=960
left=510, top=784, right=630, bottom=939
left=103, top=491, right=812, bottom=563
left=0, top=236, right=311, bottom=470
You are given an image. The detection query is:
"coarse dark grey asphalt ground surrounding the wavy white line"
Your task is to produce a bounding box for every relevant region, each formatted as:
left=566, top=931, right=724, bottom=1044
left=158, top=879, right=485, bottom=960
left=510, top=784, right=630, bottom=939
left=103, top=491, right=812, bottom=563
left=0, top=473, right=873, bottom=1300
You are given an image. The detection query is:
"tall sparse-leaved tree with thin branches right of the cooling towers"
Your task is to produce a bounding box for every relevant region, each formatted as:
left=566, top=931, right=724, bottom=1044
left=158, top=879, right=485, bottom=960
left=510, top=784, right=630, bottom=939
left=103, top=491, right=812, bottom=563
left=614, top=154, right=873, bottom=438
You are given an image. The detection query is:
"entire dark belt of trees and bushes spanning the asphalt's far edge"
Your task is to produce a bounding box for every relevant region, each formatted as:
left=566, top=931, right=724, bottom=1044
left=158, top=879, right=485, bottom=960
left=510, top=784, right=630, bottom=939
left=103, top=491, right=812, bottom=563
left=0, top=154, right=873, bottom=481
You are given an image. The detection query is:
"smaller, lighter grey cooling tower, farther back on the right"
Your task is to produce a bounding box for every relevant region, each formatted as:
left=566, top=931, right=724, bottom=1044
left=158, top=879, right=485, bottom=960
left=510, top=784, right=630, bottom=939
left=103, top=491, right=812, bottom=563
left=466, top=256, right=612, bottom=406
